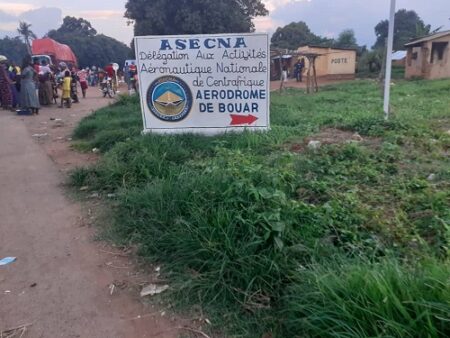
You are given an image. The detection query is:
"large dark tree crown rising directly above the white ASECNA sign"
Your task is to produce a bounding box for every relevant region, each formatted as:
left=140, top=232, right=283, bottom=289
left=125, top=0, right=268, bottom=35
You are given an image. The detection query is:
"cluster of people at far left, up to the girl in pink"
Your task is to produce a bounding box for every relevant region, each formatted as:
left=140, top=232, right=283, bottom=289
left=0, top=55, right=88, bottom=115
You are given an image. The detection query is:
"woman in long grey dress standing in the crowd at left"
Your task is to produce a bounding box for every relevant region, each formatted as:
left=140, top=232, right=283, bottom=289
left=20, top=55, right=40, bottom=115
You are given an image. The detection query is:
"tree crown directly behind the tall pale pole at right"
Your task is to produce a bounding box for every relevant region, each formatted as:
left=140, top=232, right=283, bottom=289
left=373, top=9, right=431, bottom=50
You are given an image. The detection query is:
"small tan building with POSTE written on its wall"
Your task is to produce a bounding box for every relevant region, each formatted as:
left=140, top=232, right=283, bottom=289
left=298, top=46, right=356, bottom=77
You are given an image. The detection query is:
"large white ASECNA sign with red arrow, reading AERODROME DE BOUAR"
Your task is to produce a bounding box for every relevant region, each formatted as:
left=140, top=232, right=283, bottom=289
left=134, top=34, right=270, bottom=135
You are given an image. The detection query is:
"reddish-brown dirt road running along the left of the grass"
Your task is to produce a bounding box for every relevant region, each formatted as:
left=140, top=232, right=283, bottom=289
left=0, top=90, right=179, bottom=338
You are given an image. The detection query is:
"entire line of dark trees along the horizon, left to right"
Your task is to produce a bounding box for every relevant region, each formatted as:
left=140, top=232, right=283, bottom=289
left=0, top=0, right=433, bottom=71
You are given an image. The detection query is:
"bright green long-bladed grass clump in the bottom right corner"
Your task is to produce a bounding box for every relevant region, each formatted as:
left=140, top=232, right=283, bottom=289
left=282, top=260, right=450, bottom=338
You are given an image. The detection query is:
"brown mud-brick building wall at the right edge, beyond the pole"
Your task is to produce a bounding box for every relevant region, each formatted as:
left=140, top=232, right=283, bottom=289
left=405, top=35, right=450, bottom=79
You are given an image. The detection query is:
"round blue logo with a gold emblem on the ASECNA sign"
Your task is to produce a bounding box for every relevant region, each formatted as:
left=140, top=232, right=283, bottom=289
left=147, top=76, right=192, bottom=122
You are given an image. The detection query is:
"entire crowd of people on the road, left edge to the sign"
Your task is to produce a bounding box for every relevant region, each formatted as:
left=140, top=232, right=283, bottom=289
left=0, top=55, right=137, bottom=114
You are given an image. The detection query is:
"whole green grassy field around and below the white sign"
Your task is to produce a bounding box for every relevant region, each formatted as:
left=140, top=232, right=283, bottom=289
left=71, top=80, right=450, bottom=337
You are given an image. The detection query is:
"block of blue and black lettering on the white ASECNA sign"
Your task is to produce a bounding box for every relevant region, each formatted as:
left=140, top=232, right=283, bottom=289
left=137, top=36, right=269, bottom=114
